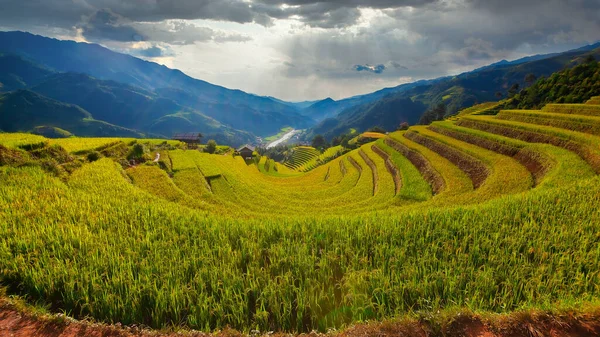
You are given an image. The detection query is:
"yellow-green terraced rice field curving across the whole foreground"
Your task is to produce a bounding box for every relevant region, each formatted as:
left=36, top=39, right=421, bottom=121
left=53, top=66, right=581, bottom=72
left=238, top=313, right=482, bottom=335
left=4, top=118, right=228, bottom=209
left=0, top=100, right=600, bottom=332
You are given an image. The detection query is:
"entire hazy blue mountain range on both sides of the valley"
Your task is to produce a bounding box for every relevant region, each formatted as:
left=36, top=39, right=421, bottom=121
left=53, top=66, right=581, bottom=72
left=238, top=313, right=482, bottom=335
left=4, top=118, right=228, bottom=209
left=0, top=32, right=600, bottom=145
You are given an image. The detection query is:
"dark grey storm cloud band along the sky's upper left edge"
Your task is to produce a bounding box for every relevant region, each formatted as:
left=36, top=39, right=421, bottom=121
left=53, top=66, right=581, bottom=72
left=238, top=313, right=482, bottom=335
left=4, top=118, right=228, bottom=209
left=0, top=0, right=438, bottom=31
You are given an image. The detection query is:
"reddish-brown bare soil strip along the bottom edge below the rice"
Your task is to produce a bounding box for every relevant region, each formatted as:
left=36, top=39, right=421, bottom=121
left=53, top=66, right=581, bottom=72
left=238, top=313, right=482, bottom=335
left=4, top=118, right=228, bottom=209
left=0, top=300, right=600, bottom=337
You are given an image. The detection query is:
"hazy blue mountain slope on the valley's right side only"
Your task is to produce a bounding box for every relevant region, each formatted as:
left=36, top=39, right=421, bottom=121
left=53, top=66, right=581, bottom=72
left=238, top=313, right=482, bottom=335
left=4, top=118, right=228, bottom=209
left=305, top=43, right=600, bottom=140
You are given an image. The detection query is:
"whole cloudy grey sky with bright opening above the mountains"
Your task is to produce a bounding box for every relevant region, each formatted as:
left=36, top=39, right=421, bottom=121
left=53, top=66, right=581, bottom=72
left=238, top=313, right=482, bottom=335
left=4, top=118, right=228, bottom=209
left=0, top=0, right=600, bottom=101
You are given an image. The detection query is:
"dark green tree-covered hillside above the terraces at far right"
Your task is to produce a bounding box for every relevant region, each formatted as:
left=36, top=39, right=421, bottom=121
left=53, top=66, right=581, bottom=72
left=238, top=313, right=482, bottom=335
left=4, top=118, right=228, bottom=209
left=504, top=55, right=600, bottom=109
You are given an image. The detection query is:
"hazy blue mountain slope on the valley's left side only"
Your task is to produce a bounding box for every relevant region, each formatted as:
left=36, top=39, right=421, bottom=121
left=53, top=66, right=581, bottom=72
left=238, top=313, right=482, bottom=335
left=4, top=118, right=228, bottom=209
left=0, top=32, right=314, bottom=144
